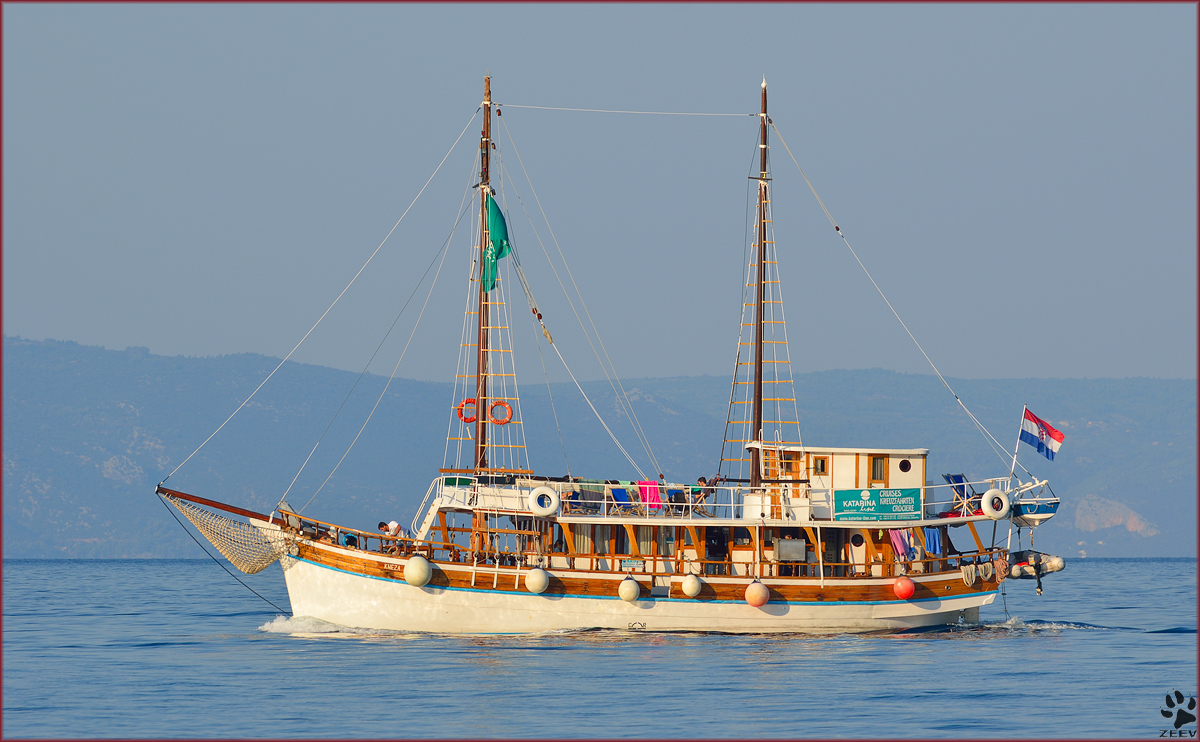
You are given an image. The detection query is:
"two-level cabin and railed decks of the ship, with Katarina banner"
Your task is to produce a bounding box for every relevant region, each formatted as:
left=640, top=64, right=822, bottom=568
left=276, top=444, right=1004, bottom=581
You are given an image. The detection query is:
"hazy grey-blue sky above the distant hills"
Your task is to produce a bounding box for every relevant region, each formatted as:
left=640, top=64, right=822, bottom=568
left=2, top=4, right=1196, bottom=381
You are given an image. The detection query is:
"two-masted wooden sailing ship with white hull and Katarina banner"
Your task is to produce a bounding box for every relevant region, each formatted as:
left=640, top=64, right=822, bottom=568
left=157, top=80, right=1062, bottom=633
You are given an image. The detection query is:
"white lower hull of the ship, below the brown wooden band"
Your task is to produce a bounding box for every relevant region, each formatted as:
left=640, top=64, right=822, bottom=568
left=281, top=556, right=996, bottom=634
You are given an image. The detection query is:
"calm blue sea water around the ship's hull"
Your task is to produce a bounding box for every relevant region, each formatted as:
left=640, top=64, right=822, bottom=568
left=4, top=560, right=1196, bottom=738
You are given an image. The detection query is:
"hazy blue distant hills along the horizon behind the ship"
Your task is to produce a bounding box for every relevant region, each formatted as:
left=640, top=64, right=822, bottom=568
left=4, top=337, right=1196, bottom=558
